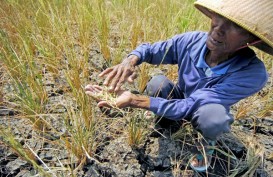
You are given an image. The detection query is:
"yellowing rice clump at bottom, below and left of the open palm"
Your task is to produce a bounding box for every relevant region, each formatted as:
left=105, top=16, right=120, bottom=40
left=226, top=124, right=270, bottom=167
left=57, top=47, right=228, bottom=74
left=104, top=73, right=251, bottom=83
left=60, top=101, right=97, bottom=174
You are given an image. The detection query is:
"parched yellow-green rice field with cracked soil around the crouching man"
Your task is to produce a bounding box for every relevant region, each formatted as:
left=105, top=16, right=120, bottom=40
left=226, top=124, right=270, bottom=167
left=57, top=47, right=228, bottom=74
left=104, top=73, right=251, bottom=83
left=0, top=0, right=273, bottom=176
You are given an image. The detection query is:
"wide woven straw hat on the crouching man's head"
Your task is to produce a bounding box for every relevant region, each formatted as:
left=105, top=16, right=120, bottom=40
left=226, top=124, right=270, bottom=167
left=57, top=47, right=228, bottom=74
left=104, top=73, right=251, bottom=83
left=194, top=0, right=273, bottom=55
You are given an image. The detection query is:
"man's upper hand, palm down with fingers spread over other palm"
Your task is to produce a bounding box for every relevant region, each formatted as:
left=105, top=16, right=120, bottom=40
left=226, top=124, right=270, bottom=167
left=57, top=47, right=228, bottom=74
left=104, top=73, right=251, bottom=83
left=99, top=55, right=139, bottom=92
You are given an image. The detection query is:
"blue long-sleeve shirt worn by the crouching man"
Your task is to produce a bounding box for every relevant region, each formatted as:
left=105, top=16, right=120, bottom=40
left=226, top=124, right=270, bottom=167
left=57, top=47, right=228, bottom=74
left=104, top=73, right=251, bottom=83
left=130, top=32, right=268, bottom=120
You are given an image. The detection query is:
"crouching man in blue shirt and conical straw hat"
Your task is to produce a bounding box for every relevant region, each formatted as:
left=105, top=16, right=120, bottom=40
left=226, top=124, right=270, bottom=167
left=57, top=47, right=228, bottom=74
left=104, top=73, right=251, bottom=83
left=86, top=0, right=273, bottom=171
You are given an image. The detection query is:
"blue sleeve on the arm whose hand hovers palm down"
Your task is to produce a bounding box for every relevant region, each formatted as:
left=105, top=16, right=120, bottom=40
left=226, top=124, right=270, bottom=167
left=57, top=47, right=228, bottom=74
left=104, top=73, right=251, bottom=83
left=129, top=34, right=187, bottom=65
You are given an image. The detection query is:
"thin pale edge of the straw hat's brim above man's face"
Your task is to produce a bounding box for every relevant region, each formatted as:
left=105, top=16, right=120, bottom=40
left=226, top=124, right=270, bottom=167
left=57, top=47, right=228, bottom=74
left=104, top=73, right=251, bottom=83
left=194, top=1, right=273, bottom=56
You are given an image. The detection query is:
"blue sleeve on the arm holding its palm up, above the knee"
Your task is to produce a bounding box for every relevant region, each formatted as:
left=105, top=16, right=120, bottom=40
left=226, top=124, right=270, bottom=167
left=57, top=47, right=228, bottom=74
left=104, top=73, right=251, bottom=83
left=150, top=59, right=268, bottom=120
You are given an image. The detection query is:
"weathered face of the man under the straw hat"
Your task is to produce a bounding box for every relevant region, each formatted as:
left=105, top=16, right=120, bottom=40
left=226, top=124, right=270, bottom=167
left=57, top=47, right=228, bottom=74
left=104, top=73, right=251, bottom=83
left=206, top=13, right=253, bottom=55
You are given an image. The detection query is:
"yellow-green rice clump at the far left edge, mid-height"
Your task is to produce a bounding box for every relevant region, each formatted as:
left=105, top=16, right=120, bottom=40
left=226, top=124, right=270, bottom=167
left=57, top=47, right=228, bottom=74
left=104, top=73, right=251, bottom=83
left=1, top=35, right=47, bottom=114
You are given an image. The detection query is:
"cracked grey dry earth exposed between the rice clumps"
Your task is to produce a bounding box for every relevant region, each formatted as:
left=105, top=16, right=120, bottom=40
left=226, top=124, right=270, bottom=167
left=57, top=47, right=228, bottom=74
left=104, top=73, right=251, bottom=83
left=0, top=47, right=273, bottom=177
